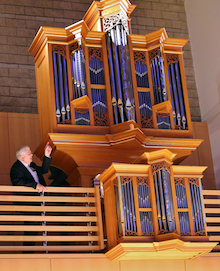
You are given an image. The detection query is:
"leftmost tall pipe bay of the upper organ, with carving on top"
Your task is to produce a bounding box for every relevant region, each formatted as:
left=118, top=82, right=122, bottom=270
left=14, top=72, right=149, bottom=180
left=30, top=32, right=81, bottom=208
left=52, top=45, right=71, bottom=124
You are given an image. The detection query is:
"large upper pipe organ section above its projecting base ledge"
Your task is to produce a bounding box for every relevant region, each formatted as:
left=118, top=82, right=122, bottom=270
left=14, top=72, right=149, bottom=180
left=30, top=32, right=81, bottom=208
left=30, top=0, right=192, bottom=141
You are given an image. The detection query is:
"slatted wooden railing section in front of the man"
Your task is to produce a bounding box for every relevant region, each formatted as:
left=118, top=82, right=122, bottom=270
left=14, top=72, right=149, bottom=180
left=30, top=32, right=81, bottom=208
left=0, top=186, right=104, bottom=253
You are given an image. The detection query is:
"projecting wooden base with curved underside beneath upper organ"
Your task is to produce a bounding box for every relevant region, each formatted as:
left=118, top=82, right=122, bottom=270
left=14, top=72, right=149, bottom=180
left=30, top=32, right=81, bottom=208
left=35, top=121, right=202, bottom=188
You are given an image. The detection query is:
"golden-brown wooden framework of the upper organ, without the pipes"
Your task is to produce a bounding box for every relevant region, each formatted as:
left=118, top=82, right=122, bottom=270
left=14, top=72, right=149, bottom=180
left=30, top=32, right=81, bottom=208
left=29, top=0, right=198, bottom=192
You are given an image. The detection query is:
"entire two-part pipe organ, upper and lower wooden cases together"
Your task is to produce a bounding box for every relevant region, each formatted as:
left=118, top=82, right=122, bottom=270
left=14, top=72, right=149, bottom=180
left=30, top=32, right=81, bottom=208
left=29, top=0, right=217, bottom=260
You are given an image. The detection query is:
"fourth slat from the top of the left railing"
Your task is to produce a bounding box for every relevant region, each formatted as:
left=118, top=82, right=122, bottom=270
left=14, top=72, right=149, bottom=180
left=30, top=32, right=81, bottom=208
left=0, top=215, right=97, bottom=222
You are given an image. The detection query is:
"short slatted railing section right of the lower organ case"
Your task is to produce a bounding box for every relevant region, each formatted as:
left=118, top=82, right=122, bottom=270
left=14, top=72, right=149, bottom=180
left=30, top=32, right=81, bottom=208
left=202, top=190, right=220, bottom=252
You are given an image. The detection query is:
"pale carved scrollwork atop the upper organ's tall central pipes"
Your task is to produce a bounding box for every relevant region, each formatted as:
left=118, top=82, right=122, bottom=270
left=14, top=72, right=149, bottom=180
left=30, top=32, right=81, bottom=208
left=103, top=13, right=129, bottom=34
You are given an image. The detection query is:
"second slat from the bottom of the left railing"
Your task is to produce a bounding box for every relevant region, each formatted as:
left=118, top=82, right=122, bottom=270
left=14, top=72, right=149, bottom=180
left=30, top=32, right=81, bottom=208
left=0, top=235, right=98, bottom=242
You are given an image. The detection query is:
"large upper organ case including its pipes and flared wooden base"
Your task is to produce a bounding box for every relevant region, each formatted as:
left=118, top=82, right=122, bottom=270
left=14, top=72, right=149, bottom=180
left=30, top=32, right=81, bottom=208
left=29, top=0, right=201, bottom=186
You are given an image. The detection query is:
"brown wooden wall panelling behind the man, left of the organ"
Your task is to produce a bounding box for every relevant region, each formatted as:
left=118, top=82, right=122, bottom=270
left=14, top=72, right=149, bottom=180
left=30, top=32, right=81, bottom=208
left=0, top=112, right=40, bottom=185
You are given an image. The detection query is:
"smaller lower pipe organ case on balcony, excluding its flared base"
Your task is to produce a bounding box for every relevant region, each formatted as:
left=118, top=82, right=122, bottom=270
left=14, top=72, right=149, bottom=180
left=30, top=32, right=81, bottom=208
left=99, top=150, right=208, bottom=253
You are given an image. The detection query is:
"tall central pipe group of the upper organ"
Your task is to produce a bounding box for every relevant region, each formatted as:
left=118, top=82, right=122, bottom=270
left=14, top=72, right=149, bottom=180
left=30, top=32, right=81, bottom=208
left=106, top=24, right=135, bottom=124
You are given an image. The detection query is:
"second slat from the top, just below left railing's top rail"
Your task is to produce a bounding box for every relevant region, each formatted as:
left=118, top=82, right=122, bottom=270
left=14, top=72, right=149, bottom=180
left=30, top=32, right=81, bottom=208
left=0, top=196, right=95, bottom=202
